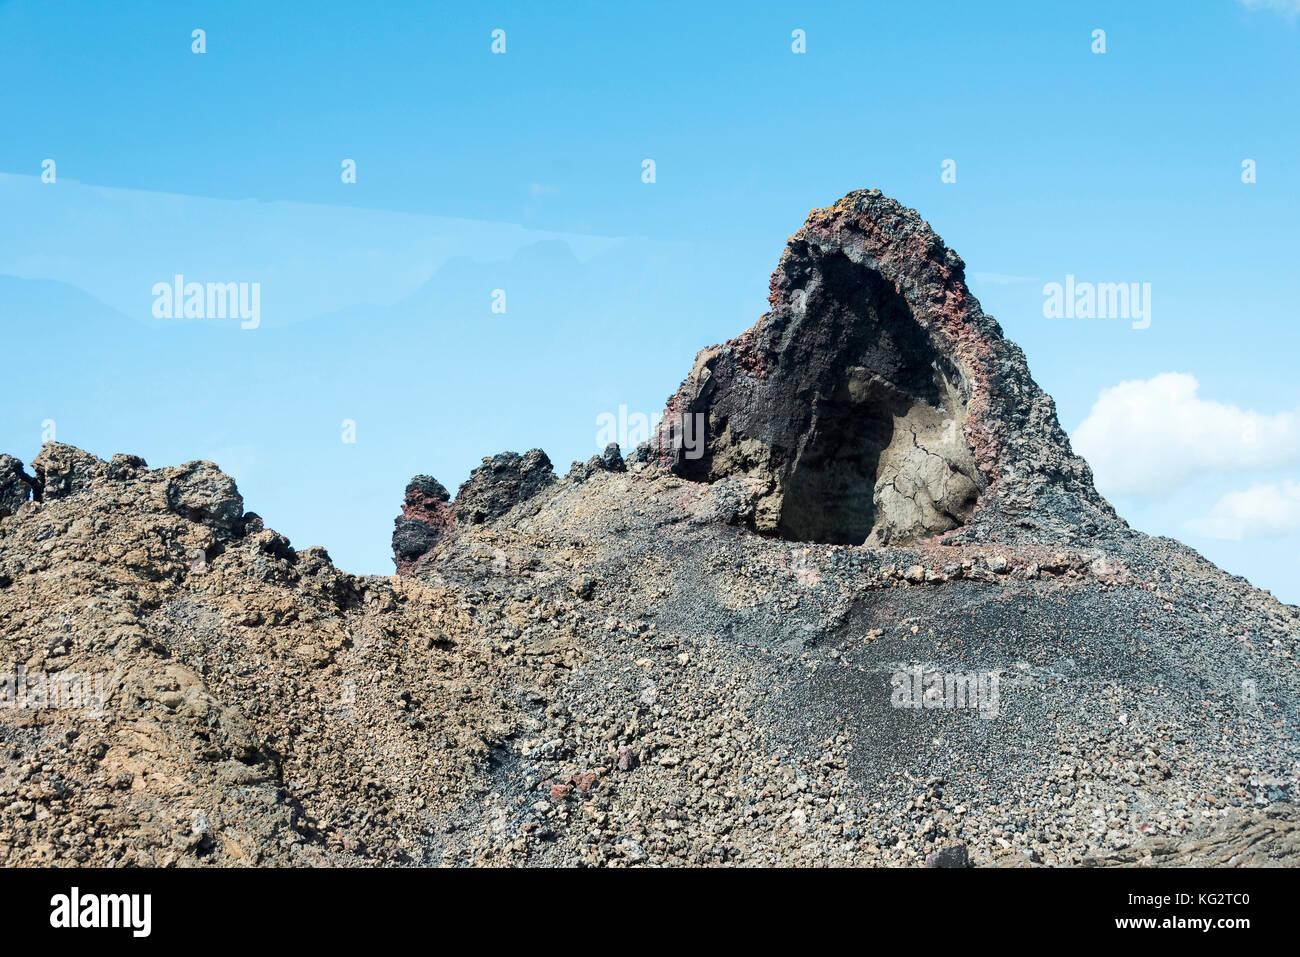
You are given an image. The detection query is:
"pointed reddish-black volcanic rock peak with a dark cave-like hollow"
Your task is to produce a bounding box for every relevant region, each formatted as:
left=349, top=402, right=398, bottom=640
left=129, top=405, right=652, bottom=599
left=657, top=190, right=1121, bottom=545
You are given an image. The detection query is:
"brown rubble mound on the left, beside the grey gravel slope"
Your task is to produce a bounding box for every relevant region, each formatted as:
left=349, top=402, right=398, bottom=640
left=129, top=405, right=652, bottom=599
left=0, top=446, right=553, bottom=865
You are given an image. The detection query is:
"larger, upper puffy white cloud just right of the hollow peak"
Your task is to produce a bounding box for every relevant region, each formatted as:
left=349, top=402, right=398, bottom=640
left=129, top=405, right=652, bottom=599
left=1071, top=372, right=1300, bottom=495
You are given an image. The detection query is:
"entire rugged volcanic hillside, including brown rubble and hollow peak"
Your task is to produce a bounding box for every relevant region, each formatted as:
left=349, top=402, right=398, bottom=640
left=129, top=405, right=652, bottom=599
left=0, top=191, right=1300, bottom=866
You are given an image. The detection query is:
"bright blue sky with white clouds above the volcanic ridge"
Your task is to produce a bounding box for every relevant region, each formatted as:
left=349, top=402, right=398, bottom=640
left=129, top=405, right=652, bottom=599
left=0, top=0, right=1300, bottom=602
